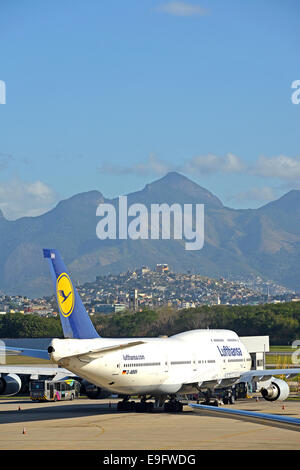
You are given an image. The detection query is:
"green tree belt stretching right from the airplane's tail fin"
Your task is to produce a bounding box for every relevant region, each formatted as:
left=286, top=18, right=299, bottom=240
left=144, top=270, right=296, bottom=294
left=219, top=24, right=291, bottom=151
left=93, top=302, right=300, bottom=345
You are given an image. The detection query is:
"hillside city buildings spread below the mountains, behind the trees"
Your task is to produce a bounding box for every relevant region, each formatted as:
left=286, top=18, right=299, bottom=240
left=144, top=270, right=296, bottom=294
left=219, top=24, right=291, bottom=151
left=0, top=264, right=300, bottom=316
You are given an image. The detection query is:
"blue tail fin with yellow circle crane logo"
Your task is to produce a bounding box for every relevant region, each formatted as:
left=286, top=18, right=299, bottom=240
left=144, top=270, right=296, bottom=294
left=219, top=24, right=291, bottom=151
left=43, top=249, right=99, bottom=339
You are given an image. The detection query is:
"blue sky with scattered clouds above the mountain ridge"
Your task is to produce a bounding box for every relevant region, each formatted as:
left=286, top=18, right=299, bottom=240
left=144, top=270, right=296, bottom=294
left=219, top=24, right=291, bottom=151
left=0, top=0, right=300, bottom=219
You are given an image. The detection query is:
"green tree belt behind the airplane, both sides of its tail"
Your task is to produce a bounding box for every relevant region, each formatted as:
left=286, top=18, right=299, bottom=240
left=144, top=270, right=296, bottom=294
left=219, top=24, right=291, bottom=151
left=0, top=302, right=300, bottom=346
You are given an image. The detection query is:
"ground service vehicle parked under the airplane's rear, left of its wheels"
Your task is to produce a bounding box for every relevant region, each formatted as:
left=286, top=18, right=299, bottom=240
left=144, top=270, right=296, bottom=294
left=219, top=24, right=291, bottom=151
left=29, top=379, right=80, bottom=401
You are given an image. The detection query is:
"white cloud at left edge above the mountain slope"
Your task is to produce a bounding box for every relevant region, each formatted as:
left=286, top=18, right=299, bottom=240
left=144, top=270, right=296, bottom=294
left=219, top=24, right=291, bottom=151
left=0, top=179, right=58, bottom=220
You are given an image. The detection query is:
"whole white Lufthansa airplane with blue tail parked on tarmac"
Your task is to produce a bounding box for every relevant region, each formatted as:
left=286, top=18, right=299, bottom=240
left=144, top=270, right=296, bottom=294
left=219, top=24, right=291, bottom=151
left=0, top=249, right=300, bottom=412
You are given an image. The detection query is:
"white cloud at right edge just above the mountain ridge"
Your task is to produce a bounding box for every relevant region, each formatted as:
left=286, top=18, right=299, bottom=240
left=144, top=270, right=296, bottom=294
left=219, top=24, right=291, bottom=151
left=251, top=155, right=300, bottom=181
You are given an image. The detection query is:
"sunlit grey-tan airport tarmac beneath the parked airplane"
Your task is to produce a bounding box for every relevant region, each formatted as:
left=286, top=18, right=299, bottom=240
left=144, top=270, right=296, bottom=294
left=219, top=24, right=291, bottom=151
left=0, top=397, right=300, bottom=451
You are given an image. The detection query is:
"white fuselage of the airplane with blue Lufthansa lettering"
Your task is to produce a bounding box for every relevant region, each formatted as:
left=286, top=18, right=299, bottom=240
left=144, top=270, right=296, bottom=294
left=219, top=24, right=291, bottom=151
left=51, top=330, right=251, bottom=395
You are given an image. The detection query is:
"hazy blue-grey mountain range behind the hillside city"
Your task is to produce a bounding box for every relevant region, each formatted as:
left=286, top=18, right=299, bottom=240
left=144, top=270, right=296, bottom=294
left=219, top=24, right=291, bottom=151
left=0, top=172, right=300, bottom=297
